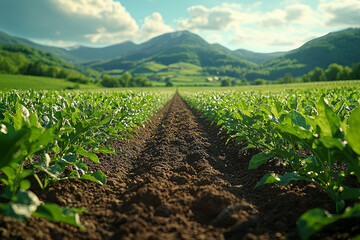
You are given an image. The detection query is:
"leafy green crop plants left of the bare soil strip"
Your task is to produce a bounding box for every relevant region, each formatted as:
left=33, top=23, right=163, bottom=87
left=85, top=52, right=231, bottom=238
left=0, top=90, right=173, bottom=229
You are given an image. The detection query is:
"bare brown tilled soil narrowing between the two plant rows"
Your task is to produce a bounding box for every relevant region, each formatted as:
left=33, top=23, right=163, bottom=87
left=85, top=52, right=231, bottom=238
left=0, top=94, right=360, bottom=240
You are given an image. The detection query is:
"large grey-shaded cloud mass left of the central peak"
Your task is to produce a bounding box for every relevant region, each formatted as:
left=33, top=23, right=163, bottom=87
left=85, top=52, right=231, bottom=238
left=0, top=0, right=171, bottom=45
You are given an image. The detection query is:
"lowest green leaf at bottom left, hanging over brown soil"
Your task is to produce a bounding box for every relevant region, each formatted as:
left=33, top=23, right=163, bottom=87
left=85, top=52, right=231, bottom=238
left=32, top=203, right=86, bottom=231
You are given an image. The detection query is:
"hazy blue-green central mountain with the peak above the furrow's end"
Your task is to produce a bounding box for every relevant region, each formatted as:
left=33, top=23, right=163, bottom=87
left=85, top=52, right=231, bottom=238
left=92, top=31, right=257, bottom=70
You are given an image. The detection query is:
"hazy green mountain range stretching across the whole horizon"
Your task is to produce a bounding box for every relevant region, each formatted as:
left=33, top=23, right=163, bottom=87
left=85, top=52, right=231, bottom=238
left=0, top=28, right=360, bottom=80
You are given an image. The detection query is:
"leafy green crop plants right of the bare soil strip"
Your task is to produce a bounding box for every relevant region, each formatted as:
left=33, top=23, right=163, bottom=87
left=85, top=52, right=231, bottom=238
left=181, top=87, right=360, bottom=239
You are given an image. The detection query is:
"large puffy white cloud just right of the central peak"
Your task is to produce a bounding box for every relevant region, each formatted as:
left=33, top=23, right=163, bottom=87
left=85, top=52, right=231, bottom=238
left=177, top=1, right=320, bottom=51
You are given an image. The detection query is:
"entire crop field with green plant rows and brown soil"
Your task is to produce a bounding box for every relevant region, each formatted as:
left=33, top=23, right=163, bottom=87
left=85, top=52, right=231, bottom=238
left=0, top=81, right=360, bottom=239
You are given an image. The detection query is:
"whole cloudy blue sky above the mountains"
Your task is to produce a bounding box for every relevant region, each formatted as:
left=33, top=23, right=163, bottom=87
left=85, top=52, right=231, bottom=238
left=0, top=0, right=360, bottom=52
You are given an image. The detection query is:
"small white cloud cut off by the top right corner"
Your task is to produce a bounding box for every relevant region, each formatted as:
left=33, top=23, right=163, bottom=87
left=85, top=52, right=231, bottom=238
left=318, top=0, right=360, bottom=26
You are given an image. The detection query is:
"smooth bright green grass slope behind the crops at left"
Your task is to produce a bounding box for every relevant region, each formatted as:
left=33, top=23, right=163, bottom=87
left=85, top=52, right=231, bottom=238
left=0, top=74, right=101, bottom=90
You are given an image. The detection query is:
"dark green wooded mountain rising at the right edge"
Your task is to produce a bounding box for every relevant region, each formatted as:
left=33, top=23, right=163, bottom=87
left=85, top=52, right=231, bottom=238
left=261, top=28, right=360, bottom=78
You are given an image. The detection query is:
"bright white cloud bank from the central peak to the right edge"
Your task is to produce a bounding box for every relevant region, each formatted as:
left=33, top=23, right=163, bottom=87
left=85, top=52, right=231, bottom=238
left=177, top=0, right=360, bottom=51
